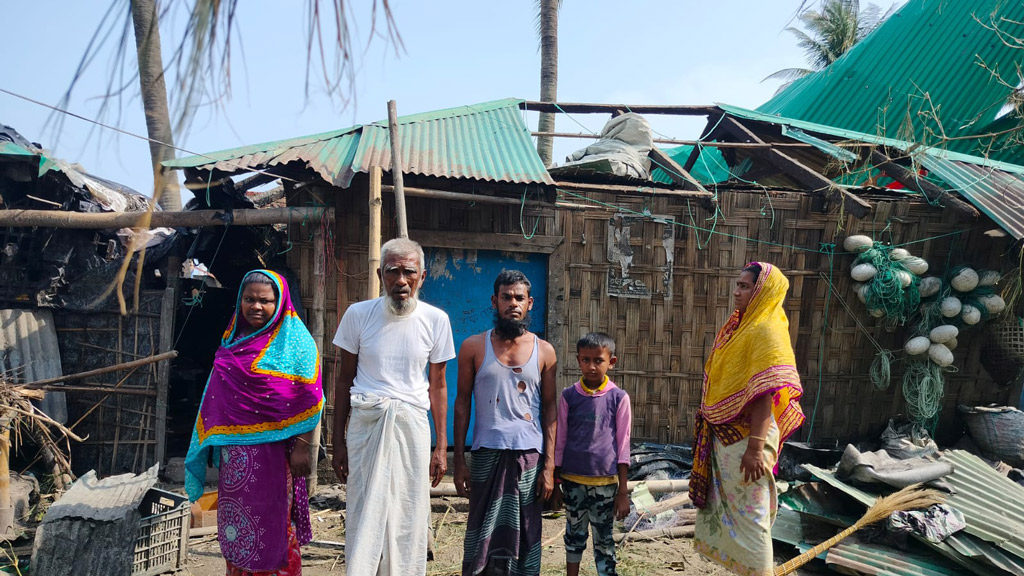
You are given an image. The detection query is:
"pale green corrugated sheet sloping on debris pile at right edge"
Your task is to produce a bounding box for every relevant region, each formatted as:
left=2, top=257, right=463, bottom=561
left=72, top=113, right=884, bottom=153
left=939, top=450, right=1024, bottom=559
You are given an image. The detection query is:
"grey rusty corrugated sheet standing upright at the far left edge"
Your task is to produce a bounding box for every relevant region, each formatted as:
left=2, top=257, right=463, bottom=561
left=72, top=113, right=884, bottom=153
left=0, top=310, right=68, bottom=423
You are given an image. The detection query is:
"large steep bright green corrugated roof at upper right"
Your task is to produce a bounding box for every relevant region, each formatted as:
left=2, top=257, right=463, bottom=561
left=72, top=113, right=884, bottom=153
left=758, top=0, right=1024, bottom=158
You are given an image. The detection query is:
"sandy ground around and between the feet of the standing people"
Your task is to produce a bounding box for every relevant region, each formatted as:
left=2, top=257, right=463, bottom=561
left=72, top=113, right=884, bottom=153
left=179, top=487, right=729, bottom=576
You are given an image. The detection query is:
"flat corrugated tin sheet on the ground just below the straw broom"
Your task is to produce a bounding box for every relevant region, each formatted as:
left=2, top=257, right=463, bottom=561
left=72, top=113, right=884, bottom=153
left=825, top=538, right=964, bottom=576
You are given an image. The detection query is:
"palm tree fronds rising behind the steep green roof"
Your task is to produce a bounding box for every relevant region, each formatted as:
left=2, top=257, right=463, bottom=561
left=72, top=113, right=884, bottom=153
left=762, top=0, right=896, bottom=90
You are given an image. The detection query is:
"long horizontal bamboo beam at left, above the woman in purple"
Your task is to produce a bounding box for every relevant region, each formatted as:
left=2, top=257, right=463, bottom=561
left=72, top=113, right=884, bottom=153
left=0, top=206, right=334, bottom=230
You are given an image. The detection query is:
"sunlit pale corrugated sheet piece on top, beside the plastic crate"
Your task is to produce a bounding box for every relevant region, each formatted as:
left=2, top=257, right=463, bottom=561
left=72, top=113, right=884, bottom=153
left=43, top=464, right=160, bottom=524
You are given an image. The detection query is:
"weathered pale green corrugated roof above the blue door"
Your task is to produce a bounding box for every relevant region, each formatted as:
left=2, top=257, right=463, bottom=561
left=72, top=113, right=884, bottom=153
left=164, top=98, right=553, bottom=188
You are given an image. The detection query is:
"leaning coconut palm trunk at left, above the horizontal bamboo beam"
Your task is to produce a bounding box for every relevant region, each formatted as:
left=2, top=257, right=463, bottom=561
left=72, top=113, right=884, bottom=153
left=131, top=0, right=181, bottom=210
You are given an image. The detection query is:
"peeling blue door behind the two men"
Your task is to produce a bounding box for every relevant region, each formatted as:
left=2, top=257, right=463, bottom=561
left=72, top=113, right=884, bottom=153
left=420, top=248, right=548, bottom=446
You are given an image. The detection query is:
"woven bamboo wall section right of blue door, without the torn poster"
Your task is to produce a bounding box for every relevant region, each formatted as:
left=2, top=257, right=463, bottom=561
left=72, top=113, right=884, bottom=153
left=559, top=191, right=1008, bottom=442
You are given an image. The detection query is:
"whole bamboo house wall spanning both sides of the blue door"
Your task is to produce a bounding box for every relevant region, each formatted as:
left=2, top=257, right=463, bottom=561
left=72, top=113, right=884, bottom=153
left=289, top=180, right=1008, bottom=445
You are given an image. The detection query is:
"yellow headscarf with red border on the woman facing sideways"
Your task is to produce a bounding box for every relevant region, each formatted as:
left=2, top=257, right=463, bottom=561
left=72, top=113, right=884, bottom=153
left=690, top=262, right=804, bottom=507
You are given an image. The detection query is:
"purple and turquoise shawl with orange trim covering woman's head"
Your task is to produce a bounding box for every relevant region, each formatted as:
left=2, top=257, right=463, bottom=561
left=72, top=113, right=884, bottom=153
left=185, top=270, right=324, bottom=500
